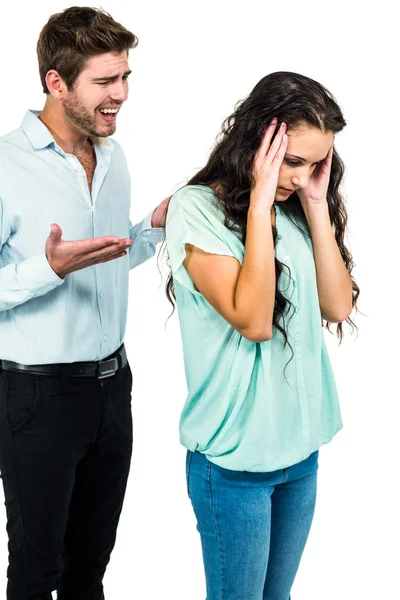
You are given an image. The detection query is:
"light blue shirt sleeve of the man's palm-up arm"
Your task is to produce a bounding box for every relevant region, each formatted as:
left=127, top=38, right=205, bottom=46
left=0, top=198, right=64, bottom=311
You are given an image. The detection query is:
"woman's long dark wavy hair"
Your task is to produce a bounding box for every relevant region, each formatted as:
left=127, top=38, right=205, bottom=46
left=166, top=71, right=360, bottom=354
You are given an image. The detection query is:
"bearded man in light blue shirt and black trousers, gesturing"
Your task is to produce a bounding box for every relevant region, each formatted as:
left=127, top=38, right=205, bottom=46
left=0, top=7, right=168, bottom=600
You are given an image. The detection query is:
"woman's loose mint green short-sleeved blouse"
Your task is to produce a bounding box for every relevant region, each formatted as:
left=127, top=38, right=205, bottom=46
left=166, top=185, right=342, bottom=472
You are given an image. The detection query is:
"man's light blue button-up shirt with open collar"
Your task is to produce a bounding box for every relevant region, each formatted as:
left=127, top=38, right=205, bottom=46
left=0, top=111, right=164, bottom=365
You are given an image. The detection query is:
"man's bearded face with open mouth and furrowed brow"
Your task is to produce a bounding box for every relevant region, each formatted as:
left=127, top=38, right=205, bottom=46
left=62, top=51, right=131, bottom=137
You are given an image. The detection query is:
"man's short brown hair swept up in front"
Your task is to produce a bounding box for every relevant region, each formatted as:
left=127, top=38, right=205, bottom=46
left=37, top=6, right=139, bottom=94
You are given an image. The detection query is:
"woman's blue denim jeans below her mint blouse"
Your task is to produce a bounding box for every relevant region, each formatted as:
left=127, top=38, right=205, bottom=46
left=186, top=451, right=318, bottom=600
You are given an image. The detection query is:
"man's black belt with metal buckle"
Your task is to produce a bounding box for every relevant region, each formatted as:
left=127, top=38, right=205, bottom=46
left=0, top=344, right=128, bottom=379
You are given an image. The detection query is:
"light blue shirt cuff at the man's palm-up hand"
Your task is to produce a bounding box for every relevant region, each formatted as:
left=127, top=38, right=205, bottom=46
left=17, top=254, right=64, bottom=296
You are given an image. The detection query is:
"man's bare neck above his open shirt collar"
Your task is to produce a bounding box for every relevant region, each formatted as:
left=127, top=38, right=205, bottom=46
left=39, top=102, right=89, bottom=154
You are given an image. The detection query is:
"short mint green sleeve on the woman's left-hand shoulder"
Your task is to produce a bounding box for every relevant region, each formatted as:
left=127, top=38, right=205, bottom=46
left=166, top=186, right=241, bottom=294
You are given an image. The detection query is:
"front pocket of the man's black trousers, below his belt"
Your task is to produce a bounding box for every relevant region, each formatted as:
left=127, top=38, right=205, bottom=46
left=5, top=371, right=39, bottom=432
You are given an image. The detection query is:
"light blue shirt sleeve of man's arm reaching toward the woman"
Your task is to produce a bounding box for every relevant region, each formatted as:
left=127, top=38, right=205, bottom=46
left=129, top=211, right=165, bottom=269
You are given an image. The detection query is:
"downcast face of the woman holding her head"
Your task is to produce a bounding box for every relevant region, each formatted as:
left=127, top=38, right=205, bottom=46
left=275, top=125, right=333, bottom=201
